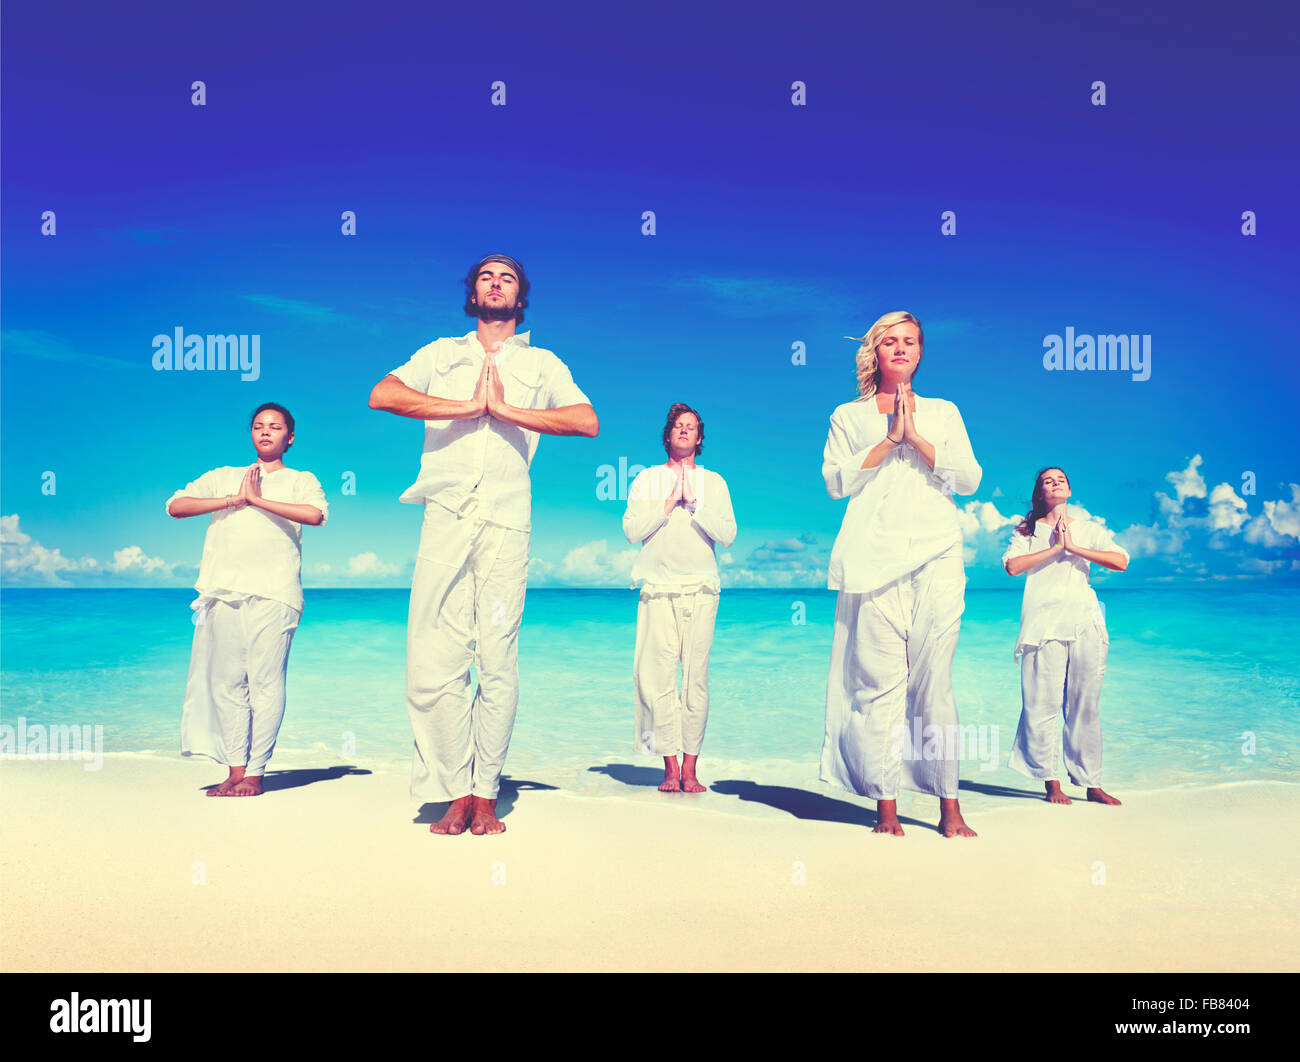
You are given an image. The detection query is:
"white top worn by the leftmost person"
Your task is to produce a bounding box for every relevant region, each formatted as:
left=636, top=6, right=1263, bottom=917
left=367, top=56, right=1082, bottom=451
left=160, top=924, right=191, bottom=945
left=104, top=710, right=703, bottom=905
left=166, top=465, right=329, bottom=612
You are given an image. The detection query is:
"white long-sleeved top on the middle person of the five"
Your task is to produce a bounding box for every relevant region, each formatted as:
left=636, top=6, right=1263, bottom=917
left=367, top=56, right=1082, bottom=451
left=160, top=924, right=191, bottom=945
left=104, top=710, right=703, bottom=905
left=623, top=464, right=736, bottom=594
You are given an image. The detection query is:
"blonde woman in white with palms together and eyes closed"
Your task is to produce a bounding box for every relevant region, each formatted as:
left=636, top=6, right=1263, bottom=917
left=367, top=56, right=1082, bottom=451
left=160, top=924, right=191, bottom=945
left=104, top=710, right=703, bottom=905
left=822, top=312, right=982, bottom=837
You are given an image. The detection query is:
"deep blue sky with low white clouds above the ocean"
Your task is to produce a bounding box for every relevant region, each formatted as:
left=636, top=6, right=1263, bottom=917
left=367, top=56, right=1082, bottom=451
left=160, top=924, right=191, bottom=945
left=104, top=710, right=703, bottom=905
left=0, top=3, right=1300, bottom=586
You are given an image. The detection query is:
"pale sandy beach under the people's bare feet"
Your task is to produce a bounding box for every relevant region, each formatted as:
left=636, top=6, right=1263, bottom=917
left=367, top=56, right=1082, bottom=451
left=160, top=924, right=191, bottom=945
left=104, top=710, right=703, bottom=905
left=0, top=755, right=1300, bottom=971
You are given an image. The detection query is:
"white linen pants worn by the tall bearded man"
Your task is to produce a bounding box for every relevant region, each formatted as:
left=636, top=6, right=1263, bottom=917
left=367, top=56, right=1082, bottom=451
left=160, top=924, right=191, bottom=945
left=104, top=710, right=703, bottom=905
left=407, top=502, right=528, bottom=802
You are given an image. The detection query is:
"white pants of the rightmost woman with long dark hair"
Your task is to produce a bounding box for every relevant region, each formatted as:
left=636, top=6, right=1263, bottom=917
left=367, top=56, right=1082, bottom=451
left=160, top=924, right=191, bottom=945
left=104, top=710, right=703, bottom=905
left=1010, top=623, right=1110, bottom=788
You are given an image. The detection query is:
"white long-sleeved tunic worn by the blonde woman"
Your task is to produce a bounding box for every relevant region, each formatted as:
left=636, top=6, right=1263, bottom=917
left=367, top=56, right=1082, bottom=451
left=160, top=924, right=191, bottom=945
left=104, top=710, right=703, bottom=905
left=822, top=395, right=983, bottom=594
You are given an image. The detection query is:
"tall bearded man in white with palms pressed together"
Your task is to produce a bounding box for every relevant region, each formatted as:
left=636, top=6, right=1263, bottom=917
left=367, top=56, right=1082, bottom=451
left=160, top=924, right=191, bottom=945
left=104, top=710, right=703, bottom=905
left=371, top=255, right=599, bottom=835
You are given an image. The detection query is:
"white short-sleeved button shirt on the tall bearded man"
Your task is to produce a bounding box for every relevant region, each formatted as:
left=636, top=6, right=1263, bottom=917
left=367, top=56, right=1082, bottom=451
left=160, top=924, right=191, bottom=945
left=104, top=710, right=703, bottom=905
left=389, top=331, right=592, bottom=532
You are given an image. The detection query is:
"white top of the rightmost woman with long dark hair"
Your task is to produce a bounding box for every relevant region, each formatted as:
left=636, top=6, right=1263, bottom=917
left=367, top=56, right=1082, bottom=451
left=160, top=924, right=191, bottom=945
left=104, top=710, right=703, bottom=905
left=1002, top=508, right=1128, bottom=656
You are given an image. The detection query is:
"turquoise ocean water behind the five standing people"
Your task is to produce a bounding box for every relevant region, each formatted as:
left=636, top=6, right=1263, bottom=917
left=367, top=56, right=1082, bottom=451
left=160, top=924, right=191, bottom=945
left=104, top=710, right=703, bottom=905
left=0, top=588, right=1300, bottom=812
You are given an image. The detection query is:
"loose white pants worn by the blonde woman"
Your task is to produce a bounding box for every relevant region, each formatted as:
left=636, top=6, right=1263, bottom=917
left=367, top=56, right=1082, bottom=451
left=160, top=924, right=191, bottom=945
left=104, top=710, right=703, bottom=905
left=822, top=546, right=966, bottom=801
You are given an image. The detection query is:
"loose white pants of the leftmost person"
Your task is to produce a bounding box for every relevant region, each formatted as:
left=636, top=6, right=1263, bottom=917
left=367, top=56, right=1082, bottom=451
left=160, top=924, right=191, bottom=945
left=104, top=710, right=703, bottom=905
left=181, top=597, right=299, bottom=777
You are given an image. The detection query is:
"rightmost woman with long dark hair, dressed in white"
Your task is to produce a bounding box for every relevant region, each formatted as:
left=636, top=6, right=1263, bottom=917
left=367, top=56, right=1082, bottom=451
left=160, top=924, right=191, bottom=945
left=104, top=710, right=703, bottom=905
left=1002, top=465, right=1128, bottom=805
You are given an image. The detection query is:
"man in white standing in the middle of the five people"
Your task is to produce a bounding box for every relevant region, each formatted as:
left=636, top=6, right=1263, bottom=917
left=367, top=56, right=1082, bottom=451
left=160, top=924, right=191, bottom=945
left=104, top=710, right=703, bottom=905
left=623, top=402, right=736, bottom=793
